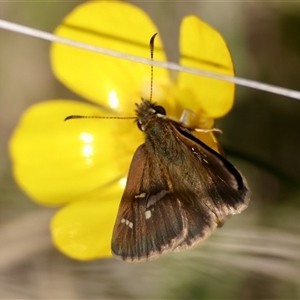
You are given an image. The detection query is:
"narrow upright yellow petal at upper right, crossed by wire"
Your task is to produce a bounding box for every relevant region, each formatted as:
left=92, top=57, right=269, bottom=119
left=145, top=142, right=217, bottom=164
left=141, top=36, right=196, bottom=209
left=178, top=16, right=234, bottom=118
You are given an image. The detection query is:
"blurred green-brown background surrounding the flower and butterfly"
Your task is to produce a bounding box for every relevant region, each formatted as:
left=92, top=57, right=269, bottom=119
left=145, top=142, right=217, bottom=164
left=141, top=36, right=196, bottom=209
left=0, top=1, right=300, bottom=299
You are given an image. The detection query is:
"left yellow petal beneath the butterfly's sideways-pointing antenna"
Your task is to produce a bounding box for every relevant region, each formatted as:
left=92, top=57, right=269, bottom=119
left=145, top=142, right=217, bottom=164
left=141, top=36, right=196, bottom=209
left=10, top=100, right=143, bottom=205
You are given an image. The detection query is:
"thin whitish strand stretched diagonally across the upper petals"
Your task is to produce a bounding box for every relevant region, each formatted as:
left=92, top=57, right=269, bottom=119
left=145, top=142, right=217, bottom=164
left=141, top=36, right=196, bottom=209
left=0, top=19, right=300, bottom=100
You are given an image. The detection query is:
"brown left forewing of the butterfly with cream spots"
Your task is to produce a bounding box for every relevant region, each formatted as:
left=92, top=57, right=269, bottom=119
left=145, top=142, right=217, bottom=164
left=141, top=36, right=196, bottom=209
left=112, top=145, right=187, bottom=261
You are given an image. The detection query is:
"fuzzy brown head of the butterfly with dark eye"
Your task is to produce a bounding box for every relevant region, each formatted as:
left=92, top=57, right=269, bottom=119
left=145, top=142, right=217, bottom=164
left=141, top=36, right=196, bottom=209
left=136, top=99, right=166, bottom=131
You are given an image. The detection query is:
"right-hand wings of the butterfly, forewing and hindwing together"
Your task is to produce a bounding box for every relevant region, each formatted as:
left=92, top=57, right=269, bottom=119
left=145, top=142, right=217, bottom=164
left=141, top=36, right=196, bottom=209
left=172, top=122, right=250, bottom=251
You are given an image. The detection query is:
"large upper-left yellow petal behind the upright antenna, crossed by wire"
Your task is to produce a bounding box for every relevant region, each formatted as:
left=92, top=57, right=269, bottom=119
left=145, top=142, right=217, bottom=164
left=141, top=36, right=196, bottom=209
left=51, top=1, right=169, bottom=115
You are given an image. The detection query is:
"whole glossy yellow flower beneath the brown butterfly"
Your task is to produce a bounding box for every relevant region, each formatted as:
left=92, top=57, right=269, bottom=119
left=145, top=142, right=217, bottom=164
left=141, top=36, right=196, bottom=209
left=10, top=1, right=234, bottom=260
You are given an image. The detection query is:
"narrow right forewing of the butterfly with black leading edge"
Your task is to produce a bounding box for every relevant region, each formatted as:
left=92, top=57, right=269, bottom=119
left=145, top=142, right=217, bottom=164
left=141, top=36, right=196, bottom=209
left=172, top=123, right=250, bottom=217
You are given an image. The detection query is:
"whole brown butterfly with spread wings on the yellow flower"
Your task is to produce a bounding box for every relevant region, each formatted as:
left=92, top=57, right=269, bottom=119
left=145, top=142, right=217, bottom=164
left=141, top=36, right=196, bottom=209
left=111, top=99, right=250, bottom=261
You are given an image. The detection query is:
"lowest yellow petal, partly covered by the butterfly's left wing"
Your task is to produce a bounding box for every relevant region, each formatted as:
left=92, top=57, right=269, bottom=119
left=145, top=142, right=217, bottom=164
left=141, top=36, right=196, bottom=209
left=51, top=185, right=121, bottom=260
